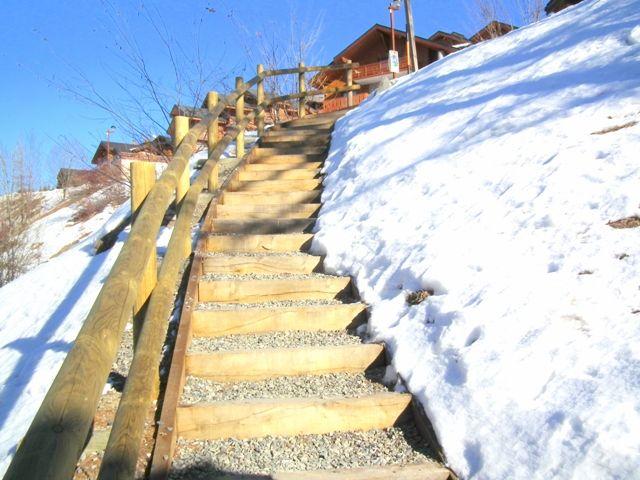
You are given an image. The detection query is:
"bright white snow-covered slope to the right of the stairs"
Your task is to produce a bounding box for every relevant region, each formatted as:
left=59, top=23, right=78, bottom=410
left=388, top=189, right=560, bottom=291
left=314, top=0, right=640, bottom=480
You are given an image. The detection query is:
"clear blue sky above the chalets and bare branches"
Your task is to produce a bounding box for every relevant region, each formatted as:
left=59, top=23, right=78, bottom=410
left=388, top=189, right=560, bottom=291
left=0, top=0, right=528, bottom=182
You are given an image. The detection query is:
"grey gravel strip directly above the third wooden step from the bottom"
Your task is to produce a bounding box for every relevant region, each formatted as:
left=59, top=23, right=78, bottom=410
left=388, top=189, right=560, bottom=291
left=189, top=330, right=362, bottom=353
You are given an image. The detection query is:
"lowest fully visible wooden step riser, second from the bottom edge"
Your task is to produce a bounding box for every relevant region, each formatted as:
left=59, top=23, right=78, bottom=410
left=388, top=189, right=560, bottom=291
left=176, top=393, right=411, bottom=440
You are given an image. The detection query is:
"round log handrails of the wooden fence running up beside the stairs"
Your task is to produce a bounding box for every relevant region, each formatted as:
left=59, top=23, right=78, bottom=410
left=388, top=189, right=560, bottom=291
left=4, top=64, right=359, bottom=480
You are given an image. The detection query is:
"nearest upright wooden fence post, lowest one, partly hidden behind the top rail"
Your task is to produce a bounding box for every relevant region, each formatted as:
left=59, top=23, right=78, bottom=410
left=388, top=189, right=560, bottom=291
left=130, top=161, right=158, bottom=348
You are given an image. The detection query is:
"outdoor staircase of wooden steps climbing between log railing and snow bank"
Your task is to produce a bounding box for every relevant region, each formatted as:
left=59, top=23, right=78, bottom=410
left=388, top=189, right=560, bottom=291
left=151, top=114, right=452, bottom=479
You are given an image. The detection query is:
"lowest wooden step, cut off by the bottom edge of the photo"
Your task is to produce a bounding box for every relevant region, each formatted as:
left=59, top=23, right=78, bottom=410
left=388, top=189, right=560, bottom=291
left=270, top=462, right=455, bottom=480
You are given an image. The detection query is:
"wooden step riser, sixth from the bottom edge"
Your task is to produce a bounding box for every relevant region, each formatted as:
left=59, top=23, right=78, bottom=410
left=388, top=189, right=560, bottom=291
left=202, top=251, right=322, bottom=275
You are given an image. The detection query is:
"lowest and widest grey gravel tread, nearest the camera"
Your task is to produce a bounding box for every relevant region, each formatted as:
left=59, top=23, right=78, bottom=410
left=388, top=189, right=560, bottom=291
left=169, top=425, right=431, bottom=480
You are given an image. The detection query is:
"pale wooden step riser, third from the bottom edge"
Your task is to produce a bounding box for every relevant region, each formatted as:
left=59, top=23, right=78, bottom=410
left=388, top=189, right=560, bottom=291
left=186, top=343, right=385, bottom=382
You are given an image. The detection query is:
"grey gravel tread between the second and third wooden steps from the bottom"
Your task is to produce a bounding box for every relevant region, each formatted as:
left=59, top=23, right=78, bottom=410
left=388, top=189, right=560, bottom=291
left=181, top=367, right=389, bottom=404
